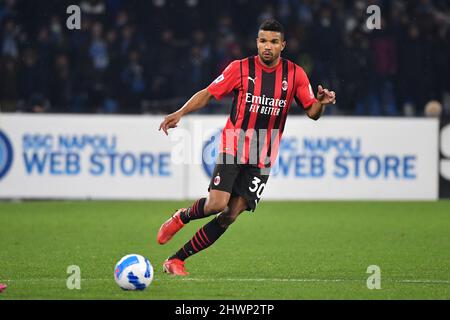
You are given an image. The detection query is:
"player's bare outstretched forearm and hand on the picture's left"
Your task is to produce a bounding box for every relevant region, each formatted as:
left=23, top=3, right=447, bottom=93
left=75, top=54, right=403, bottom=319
left=159, top=89, right=212, bottom=135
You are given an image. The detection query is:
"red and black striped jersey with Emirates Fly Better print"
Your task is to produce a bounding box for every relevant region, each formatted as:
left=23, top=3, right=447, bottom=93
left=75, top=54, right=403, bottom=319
left=207, top=56, right=317, bottom=168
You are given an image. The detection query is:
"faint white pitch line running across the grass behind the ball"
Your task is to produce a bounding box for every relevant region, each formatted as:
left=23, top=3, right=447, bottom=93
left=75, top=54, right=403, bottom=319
left=0, top=276, right=450, bottom=285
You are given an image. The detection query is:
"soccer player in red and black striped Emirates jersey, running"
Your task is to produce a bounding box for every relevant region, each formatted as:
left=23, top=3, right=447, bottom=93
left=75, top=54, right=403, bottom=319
left=157, top=20, right=336, bottom=276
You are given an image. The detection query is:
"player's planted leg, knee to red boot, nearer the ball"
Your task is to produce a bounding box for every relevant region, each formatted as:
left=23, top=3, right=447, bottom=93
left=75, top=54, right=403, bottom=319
left=163, top=197, right=247, bottom=276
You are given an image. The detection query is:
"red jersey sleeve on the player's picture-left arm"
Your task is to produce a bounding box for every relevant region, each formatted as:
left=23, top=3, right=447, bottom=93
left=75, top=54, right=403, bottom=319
left=207, top=60, right=241, bottom=100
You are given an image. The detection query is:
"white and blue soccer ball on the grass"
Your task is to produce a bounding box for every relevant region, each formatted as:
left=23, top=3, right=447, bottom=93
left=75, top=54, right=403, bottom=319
left=114, top=254, right=153, bottom=290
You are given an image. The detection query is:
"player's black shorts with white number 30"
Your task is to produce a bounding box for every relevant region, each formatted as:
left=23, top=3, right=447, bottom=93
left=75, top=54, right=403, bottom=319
left=208, top=154, right=270, bottom=212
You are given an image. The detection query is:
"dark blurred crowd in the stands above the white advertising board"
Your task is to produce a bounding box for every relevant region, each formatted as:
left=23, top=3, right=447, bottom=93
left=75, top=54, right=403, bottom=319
left=0, top=0, right=450, bottom=116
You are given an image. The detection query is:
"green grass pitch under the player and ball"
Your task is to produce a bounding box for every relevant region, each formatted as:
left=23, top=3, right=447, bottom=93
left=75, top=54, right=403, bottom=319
left=0, top=201, right=450, bottom=300
